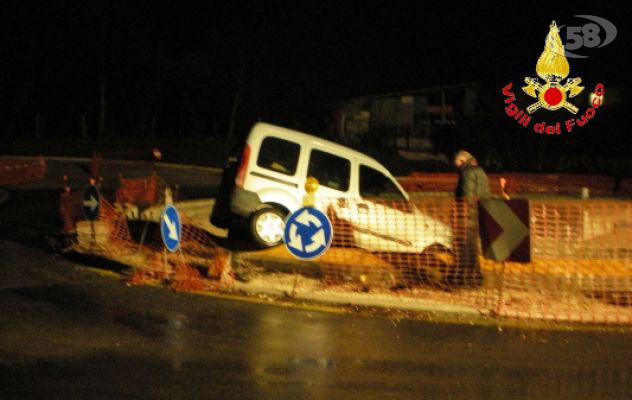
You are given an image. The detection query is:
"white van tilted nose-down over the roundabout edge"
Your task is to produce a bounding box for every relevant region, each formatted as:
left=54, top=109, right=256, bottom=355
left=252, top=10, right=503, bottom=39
left=211, top=123, right=452, bottom=253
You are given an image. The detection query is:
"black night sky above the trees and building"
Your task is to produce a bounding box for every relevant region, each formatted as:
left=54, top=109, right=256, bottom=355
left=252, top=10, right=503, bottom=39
left=0, top=0, right=632, bottom=158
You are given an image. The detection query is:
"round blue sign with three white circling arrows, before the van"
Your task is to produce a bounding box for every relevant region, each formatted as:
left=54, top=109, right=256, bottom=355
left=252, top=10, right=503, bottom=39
left=283, top=207, right=333, bottom=260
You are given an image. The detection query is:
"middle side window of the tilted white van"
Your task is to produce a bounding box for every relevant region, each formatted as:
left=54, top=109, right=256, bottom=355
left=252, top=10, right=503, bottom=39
left=307, top=149, right=351, bottom=192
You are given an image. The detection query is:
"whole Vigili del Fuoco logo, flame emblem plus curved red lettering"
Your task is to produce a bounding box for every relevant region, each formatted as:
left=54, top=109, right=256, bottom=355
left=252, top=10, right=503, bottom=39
left=502, top=21, right=605, bottom=135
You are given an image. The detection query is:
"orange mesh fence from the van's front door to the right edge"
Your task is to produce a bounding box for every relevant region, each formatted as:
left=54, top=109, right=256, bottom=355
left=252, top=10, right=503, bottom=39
left=312, top=198, right=632, bottom=323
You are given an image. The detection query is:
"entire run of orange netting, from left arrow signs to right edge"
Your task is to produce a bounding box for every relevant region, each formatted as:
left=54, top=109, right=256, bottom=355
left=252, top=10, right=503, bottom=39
left=60, top=170, right=632, bottom=323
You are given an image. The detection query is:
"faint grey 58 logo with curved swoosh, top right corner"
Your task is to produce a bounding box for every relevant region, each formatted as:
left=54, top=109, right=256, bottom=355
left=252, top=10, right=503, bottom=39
left=547, top=15, right=617, bottom=58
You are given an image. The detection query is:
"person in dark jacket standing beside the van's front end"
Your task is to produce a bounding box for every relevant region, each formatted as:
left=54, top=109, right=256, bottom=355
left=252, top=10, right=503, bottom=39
left=453, top=150, right=490, bottom=287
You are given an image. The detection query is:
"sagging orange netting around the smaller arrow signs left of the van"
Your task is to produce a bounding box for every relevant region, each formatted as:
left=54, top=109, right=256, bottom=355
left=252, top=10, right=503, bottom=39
left=60, top=180, right=229, bottom=290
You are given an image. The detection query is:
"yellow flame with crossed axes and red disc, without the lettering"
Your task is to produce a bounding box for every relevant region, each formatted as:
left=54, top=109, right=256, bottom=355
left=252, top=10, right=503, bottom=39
left=522, top=21, right=584, bottom=114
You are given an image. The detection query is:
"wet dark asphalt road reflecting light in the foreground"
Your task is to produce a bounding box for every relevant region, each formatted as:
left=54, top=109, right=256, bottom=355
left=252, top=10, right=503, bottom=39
left=0, top=158, right=632, bottom=399
